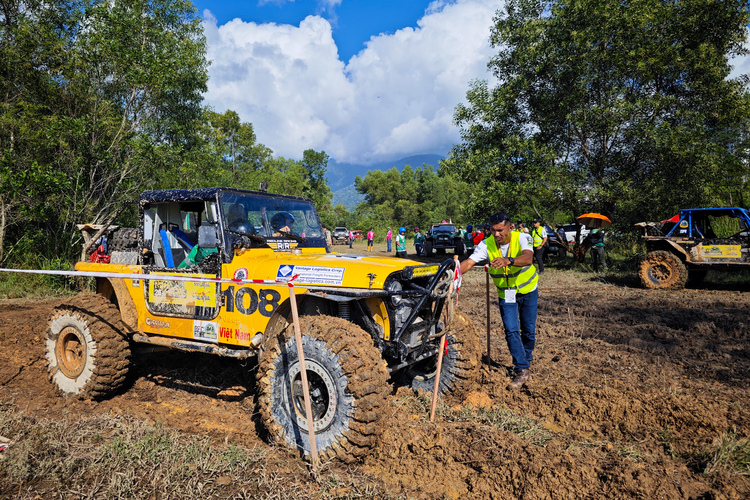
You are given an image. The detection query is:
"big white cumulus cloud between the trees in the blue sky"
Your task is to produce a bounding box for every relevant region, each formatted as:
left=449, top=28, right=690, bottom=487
left=204, top=0, right=502, bottom=163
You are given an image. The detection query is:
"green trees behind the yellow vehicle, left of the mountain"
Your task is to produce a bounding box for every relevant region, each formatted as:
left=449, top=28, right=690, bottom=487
left=0, top=0, right=331, bottom=268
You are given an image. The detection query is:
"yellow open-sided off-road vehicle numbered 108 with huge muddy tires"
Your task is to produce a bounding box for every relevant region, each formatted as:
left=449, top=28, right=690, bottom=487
left=47, top=188, right=480, bottom=461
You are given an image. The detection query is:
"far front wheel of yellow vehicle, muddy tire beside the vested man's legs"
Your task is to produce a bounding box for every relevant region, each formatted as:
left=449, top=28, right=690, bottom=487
left=398, top=313, right=482, bottom=396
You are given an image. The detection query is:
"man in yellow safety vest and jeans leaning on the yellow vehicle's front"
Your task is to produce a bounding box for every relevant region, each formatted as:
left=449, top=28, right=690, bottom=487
left=461, top=213, right=539, bottom=389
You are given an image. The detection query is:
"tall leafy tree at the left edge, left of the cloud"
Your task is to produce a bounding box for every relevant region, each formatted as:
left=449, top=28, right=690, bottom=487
left=0, top=0, right=208, bottom=262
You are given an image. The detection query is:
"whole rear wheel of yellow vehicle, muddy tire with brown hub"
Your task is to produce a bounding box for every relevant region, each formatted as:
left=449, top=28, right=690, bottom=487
left=45, top=295, right=130, bottom=400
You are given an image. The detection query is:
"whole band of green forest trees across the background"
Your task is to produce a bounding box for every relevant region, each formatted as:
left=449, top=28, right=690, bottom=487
left=0, top=0, right=750, bottom=276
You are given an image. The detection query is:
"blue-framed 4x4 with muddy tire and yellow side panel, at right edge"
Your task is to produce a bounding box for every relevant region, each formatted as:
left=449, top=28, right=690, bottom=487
left=636, top=207, right=750, bottom=289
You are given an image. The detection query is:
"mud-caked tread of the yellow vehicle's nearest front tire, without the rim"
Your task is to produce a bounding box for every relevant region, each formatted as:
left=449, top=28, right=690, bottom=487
left=257, top=316, right=389, bottom=463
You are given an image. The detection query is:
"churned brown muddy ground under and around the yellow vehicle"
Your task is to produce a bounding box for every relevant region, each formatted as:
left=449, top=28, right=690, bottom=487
left=0, top=244, right=750, bottom=499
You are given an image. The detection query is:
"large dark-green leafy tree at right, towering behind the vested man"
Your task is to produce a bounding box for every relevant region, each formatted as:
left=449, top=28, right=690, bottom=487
left=447, top=0, right=750, bottom=227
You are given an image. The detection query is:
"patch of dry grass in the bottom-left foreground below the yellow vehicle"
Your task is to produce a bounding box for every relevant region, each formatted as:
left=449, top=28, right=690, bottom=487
left=0, top=403, right=389, bottom=499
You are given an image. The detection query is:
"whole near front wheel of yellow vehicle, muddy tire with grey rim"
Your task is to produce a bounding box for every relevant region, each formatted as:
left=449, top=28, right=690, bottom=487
left=257, top=316, right=389, bottom=463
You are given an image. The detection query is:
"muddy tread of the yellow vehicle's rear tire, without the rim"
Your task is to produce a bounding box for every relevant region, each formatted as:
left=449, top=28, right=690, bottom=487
left=49, top=295, right=130, bottom=400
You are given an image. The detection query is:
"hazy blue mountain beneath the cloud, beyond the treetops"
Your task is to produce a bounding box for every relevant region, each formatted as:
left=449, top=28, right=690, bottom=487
left=326, top=154, right=445, bottom=210
